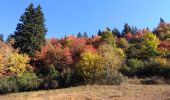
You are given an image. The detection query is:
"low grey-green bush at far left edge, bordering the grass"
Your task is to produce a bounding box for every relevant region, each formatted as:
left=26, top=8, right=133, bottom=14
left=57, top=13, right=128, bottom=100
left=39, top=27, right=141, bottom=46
left=0, top=77, right=19, bottom=94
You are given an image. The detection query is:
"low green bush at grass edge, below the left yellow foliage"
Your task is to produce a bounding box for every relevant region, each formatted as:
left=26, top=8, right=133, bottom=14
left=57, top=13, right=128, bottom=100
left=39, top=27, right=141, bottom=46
left=17, top=72, right=41, bottom=91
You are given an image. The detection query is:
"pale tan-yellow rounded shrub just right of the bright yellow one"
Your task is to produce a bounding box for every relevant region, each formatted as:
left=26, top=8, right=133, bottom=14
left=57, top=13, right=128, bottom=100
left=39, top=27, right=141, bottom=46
left=98, top=44, right=125, bottom=70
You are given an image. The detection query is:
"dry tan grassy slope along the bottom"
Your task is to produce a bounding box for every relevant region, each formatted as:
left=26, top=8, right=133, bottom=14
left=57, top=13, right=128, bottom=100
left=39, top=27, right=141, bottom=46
left=0, top=85, right=170, bottom=100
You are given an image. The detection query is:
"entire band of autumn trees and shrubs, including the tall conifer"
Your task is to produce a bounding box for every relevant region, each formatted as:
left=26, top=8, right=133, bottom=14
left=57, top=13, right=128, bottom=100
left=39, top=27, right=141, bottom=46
left=0, top=4, right=170, bottom=94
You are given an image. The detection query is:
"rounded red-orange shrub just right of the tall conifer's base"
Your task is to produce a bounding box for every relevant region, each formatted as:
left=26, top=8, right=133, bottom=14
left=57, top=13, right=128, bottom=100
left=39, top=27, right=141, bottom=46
left=35, top=44, right=73, bottom=75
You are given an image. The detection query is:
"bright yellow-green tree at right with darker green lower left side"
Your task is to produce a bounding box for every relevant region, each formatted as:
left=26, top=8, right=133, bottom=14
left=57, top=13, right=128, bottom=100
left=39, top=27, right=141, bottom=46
left=127, top=33, right=159, bottom=60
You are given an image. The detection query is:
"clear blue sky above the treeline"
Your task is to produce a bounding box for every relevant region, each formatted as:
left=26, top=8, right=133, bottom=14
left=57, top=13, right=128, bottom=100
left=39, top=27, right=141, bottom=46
left=0, top=0, right=170, bottom=38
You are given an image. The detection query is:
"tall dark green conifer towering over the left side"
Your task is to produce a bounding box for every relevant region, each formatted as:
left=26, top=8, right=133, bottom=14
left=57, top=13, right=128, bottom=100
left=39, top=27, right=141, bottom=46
left=13, top=3, right=47, bottom=56
